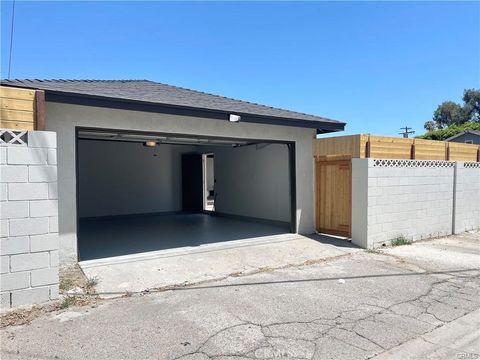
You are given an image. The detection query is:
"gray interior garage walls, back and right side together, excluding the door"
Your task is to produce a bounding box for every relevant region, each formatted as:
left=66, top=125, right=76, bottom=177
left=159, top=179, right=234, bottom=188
left=78, top=140, right=290, bottom=222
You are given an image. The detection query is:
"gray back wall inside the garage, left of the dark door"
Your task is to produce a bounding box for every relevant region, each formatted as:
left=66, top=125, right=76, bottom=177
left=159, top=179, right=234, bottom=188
left=78, top=140, right=196, bottom=217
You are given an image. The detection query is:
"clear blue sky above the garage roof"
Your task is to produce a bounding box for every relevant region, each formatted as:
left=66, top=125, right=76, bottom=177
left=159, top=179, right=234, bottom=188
left=1, top=1, right=480, bottom=135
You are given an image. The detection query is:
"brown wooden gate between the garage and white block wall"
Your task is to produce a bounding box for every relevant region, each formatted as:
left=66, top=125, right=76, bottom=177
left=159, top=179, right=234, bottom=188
left=315, top=155, right=352, bottom=237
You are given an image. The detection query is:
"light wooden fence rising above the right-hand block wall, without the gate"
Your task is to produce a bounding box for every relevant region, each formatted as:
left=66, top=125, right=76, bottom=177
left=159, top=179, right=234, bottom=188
left=313, top=134, right=480, bottom=161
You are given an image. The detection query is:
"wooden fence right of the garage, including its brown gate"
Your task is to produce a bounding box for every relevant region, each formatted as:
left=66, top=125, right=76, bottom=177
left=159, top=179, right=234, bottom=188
left=313, top=134, right=480, bottom=237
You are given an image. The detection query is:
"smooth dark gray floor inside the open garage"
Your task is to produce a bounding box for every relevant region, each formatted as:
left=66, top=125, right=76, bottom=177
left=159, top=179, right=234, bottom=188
left=79, top=214, right=289, bottom=261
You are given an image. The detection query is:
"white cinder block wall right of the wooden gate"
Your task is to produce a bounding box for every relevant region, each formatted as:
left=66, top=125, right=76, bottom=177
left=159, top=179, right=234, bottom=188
left=352, top=159, right=480, bottom=248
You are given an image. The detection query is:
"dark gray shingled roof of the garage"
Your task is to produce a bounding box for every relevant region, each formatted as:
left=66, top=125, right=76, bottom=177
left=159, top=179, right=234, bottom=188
left=1, top=79, right=345, bottom=131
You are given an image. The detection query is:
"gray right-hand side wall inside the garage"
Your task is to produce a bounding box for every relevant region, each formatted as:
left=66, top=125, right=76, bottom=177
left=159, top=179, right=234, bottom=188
left=214, top=144, right=290, bottom=222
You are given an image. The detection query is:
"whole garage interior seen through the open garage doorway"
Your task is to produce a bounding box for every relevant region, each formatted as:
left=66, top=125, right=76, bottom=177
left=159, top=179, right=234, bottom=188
left=77, top=129, right=296, bottom=261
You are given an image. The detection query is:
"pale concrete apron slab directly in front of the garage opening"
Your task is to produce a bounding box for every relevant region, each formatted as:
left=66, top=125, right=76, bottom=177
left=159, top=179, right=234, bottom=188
left=80, top=234, right=361, bottom=296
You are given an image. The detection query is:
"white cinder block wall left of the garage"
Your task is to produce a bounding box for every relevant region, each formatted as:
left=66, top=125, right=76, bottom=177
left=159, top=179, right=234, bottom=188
left=0, top=130, right=59, bottom=309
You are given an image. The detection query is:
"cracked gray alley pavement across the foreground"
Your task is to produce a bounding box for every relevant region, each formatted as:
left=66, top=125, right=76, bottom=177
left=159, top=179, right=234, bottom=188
left=1, top=233, right=480, bottom=360
